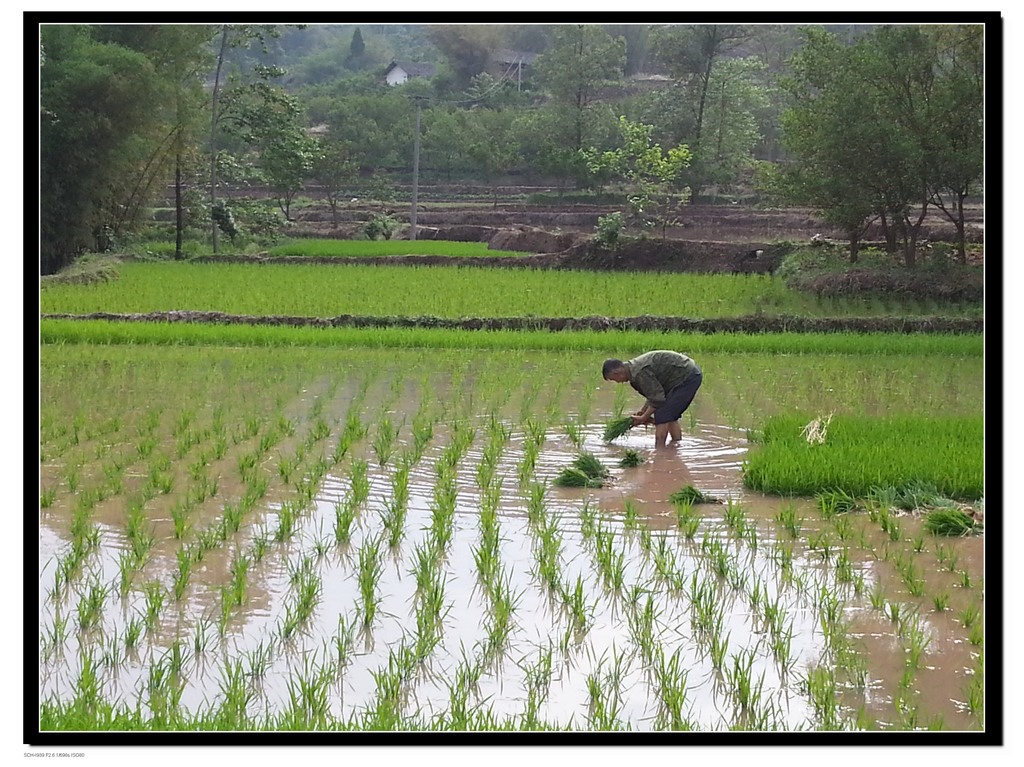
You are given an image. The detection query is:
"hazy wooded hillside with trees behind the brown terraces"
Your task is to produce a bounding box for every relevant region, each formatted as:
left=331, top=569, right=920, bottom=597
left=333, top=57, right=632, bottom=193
left=40, top=24, right=986, bottom=273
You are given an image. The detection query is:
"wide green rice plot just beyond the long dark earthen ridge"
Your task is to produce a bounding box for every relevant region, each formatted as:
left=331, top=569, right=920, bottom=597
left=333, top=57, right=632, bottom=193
left=40, top=262, right=981, bottom=318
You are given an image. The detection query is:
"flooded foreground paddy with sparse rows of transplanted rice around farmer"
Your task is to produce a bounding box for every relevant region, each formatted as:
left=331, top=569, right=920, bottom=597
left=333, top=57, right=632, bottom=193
left=39, top=346, right=984, bottom=730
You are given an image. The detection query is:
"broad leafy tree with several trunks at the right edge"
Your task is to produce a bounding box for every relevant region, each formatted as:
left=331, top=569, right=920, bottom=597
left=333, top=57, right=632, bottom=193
left=783, top=27, right=982, bottom=266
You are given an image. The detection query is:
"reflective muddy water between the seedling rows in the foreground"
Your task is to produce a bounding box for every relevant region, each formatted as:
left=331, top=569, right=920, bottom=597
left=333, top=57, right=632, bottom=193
left=39, top=414, right=984, bottom=730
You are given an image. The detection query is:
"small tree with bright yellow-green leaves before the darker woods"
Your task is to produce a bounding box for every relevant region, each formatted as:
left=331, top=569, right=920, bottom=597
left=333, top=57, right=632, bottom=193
left=582, top=117, right=691, bottom=238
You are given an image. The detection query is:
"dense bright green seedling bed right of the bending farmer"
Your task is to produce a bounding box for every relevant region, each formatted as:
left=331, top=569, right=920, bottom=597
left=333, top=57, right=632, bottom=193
left=743, top=416, right=984, bottom=500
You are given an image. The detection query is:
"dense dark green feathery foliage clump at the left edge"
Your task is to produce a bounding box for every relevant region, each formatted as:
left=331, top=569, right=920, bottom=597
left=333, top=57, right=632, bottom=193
left=40, top=25, right=186, bottom=273
